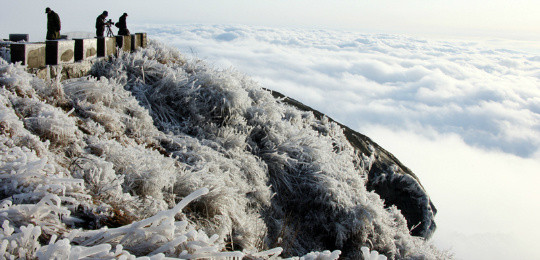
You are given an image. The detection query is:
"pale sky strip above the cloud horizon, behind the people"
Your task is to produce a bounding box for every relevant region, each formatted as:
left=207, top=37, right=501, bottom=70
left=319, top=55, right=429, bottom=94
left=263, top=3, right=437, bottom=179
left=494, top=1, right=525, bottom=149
left=0, top=0, right=540, bottom=41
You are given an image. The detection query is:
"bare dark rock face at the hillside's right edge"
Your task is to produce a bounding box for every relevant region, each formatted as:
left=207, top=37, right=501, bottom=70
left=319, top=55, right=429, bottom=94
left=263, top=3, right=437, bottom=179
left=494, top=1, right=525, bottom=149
left=270, top=91, right=437, bottom=239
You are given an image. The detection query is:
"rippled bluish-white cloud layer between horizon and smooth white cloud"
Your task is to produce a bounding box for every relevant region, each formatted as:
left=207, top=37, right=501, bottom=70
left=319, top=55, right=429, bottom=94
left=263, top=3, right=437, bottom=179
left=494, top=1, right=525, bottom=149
left=138, top=25, right=540, bottom=158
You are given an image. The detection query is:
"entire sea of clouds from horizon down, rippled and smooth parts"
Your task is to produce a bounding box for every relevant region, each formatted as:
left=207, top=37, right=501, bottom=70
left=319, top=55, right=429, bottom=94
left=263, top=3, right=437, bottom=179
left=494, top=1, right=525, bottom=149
left=132, top=25, right=540, bottom=259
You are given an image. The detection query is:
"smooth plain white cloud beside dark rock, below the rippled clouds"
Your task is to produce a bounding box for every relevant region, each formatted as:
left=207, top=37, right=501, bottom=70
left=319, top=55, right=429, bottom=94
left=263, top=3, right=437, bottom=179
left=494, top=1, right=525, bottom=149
left=366, top=126, right=540, bottom=259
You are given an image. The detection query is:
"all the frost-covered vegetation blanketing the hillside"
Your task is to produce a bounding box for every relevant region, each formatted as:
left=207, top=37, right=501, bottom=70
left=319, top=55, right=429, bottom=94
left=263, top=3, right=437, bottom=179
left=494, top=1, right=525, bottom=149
left=0, top=41, right=448, bottom=259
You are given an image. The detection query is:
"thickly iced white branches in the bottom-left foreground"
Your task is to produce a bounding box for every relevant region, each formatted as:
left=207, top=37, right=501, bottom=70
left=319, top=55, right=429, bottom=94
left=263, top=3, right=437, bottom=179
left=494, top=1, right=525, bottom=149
left=0, top=189, right=262, bottom=259
